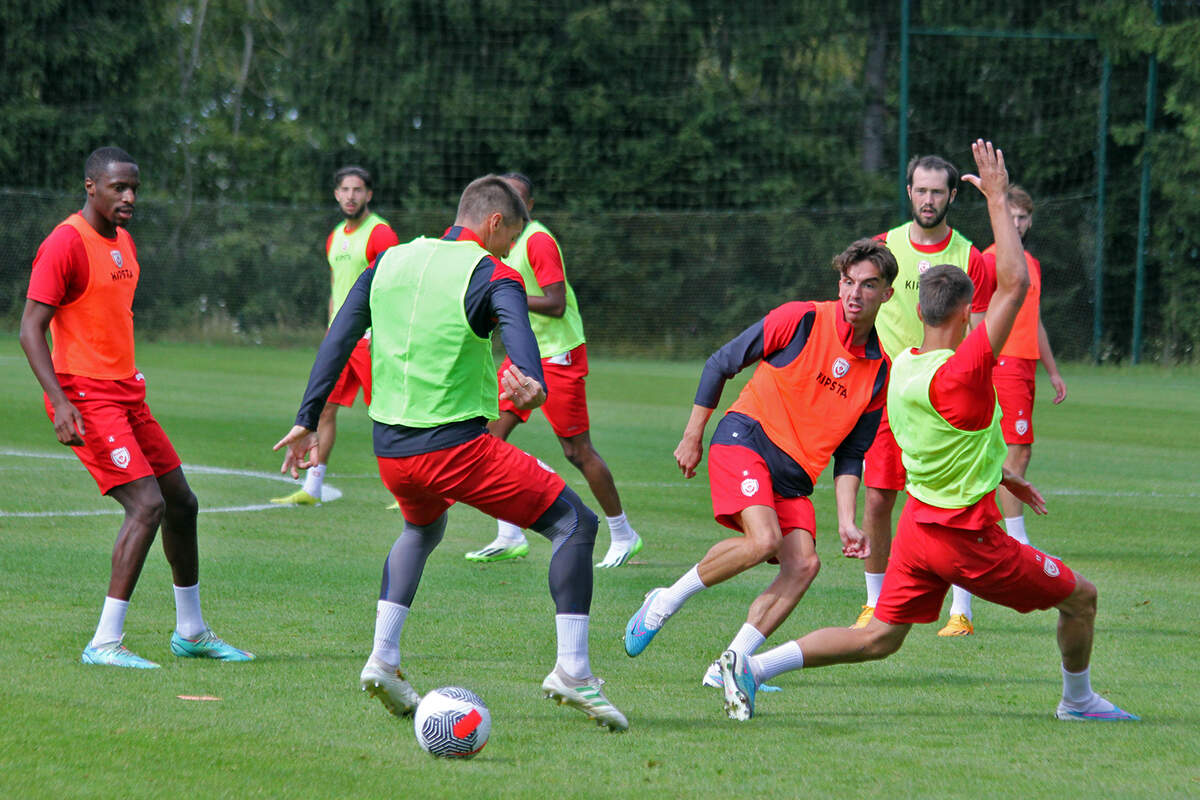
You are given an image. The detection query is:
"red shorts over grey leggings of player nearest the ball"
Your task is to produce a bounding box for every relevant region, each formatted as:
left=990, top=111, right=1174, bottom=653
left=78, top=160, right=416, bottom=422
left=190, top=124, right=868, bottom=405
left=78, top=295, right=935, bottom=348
left=379, top=433, right=566, bottom=528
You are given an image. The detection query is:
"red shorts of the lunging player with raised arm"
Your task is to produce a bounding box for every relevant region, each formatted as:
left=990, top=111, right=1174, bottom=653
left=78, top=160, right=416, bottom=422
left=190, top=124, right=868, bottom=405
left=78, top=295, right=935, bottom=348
left=875, top=504, right=1075, bottom=625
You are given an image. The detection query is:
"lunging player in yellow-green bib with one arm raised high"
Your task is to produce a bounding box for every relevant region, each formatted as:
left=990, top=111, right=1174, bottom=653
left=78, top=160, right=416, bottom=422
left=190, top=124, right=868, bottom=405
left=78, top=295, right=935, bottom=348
left=720, top=140, right=1138, bottom=721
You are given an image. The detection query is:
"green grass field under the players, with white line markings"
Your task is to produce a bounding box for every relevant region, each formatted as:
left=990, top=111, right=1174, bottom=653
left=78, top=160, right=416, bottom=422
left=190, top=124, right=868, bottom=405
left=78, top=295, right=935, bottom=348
left=0, top=339, right=1200, bottom=799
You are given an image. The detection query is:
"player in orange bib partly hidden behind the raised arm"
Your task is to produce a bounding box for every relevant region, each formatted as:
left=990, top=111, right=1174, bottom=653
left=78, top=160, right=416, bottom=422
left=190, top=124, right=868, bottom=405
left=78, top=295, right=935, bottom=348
left=955, top=185, right=1067, bottom=618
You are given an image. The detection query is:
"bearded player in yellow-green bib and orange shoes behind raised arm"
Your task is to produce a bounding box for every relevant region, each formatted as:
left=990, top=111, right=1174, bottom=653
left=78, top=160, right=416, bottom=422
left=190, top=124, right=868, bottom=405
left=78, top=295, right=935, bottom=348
left=854, top=156, right=986, bottom=636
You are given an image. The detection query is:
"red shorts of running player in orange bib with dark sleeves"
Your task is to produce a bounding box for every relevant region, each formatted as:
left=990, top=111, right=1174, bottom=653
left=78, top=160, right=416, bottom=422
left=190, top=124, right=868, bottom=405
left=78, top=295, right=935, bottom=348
left=708, top=445, right=817, bottom=539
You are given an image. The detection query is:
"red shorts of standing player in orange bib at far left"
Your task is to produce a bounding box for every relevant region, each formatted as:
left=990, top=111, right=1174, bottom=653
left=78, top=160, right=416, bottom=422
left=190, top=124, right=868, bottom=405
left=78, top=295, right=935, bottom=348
left=43, top=372, right=180, bottom=494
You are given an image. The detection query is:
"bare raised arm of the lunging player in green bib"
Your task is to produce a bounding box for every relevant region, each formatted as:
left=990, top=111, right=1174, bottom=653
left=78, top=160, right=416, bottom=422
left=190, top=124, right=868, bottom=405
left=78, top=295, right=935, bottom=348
left=962, top=139, right=1030, bottom=355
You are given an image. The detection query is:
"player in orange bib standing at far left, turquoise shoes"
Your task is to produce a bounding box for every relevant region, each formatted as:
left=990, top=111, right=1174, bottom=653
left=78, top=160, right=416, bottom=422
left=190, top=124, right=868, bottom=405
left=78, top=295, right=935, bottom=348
left=20, top=148, right=254, bottom=669
